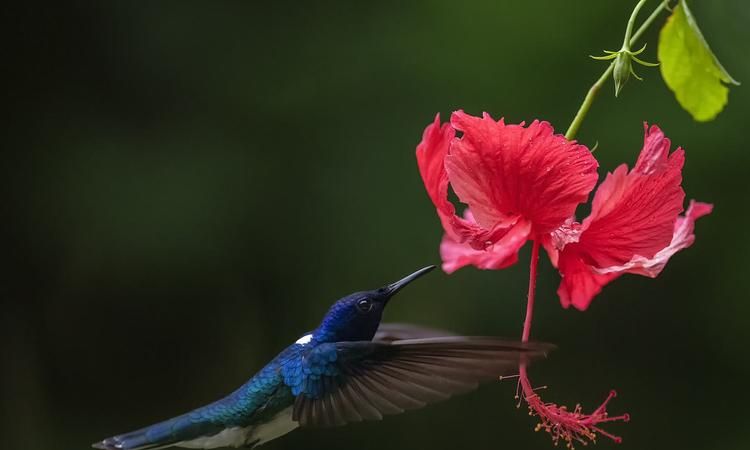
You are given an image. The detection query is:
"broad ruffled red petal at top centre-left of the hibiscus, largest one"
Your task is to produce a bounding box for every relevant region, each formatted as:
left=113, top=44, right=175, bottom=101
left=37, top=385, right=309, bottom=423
left=445, top=111, right=598, bottom=234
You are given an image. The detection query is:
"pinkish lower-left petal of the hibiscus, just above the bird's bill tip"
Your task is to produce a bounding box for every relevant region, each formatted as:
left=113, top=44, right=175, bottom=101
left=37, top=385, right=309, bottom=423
left=440, top=210, right=531, bottom=273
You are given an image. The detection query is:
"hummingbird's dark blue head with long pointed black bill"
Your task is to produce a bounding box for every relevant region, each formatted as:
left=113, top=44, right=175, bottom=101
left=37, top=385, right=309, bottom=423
left=313, top=266, right=435, bottom=342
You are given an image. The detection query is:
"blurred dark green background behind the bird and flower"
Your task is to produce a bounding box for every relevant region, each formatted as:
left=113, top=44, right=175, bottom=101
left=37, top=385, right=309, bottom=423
left=0, top=0, right=750, bottom=450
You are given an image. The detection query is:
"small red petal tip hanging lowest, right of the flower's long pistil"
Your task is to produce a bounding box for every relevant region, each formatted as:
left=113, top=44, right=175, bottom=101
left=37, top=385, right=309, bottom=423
left=557, top=244, right=620, bottom=311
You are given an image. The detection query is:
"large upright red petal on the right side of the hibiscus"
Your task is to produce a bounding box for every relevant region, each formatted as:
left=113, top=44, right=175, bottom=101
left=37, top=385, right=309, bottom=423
left=579, top=126, right=685, bottom=268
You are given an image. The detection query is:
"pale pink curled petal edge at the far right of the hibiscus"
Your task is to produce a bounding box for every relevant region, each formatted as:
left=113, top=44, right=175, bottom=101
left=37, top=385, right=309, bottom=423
left=595, top=200, right=713, bottom=278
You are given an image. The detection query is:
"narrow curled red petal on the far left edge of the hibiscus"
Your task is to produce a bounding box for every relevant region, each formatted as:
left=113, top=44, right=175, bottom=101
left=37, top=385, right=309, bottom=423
left=417, top=114, right=519, bottom=249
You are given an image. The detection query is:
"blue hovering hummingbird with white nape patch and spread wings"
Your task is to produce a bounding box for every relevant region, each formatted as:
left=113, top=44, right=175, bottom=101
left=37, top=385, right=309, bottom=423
left=92, top=266, right=552, bottom=450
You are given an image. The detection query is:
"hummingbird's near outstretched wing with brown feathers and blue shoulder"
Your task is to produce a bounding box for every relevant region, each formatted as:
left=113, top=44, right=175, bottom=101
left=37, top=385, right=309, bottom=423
left=292, top=336, right=552, bottom=427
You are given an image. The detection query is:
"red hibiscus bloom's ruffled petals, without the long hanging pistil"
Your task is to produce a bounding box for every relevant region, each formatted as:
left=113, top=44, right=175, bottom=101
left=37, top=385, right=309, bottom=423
left=417, top=116, right=712, bottom=310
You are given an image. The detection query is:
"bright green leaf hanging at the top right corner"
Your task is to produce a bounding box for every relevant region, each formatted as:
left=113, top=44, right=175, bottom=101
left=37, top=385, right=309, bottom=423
left=657, top=0, right=740, bottom=122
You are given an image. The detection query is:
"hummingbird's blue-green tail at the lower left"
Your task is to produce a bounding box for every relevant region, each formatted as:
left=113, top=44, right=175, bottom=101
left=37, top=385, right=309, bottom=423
left=92, top=413, right=223, bottom=450
